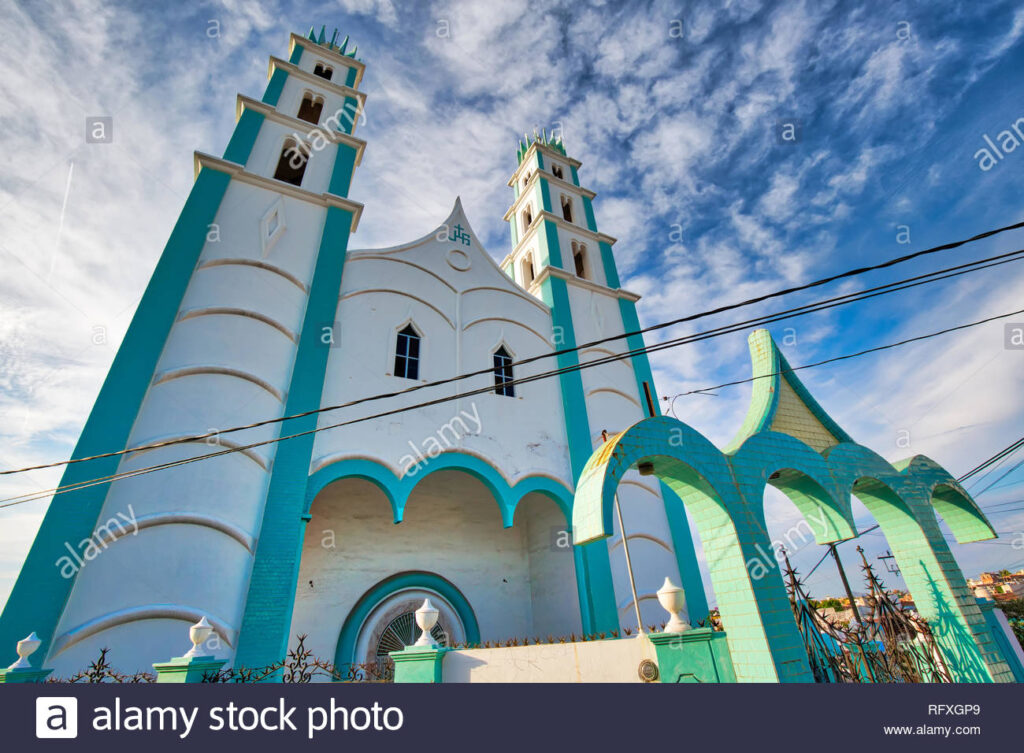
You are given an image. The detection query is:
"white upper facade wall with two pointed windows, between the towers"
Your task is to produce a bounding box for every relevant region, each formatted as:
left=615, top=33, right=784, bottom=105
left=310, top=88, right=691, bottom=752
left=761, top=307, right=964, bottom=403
left=312, top=198, right=571, bottom=487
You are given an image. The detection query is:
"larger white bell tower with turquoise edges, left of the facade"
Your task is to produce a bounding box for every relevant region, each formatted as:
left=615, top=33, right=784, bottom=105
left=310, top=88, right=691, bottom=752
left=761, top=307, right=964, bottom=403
left=0, top=23, right=366, bottom=676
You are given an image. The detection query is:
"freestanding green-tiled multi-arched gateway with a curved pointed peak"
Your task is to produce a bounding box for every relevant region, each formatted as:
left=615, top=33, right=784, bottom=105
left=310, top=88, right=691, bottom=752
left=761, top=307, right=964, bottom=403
left=572, top=330, right=1014, bottom=682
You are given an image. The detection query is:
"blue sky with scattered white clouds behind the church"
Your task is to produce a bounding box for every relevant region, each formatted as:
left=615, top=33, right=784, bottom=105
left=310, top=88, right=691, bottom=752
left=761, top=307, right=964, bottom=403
left=0, top=0, right=1024, bottom=601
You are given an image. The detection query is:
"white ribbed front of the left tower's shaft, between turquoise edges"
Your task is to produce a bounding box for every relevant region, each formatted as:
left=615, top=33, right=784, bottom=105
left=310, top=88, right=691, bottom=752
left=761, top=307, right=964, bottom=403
left=48, top=175, right=324, bottom=676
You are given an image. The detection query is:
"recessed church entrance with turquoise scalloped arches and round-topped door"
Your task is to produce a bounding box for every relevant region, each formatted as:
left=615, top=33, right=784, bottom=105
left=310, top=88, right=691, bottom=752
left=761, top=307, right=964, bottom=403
left=291, top=456, right=581, bottom=666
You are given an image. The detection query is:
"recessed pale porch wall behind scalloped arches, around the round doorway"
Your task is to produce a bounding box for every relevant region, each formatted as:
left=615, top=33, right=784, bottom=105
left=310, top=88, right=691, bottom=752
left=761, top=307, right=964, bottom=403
left=291, top=471, right=581, bottom=661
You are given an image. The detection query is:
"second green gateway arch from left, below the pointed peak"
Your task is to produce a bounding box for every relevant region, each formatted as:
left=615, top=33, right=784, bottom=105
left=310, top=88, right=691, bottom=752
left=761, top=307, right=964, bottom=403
left=730, top=431, right=856, bottom=544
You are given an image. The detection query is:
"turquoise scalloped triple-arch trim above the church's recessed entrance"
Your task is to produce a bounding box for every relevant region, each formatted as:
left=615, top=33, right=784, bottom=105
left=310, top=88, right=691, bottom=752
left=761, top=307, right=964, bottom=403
left=305, top=452, right=572, bottom=528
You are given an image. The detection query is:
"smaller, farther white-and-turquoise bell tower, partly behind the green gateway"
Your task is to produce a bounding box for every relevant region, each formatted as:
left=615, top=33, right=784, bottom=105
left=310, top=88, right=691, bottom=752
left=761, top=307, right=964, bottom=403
left=502, top=133, right=708, bottom=630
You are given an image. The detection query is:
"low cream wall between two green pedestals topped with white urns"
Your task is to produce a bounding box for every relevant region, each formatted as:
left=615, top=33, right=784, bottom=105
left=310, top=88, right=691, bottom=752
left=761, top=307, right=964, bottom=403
left=441, top=637, right=657, bottom=682
